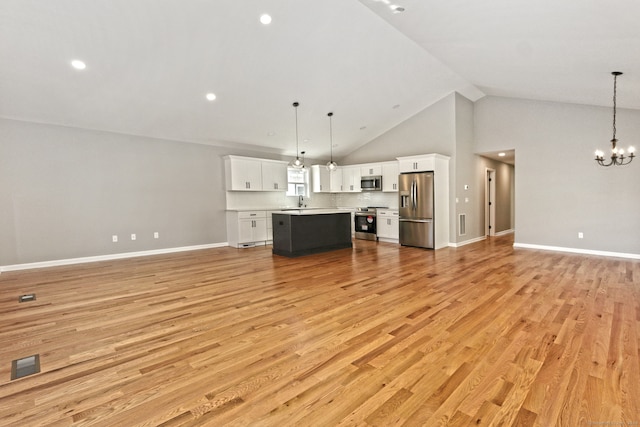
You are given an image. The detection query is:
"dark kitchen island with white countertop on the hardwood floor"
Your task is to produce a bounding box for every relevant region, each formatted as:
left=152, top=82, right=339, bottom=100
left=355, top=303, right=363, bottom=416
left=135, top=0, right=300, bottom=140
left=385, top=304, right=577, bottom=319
left=272, top=209, right=352, bottom=257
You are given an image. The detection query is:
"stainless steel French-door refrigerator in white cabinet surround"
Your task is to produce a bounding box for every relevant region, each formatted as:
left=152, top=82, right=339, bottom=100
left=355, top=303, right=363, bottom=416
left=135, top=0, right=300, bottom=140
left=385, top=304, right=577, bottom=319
left=398, top=172, right=434, bottom=249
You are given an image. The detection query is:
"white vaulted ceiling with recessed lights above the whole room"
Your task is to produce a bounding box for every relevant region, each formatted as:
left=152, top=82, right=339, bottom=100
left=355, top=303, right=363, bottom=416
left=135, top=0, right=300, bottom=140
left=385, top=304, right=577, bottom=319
left=0, top=0, right=640, bottom=158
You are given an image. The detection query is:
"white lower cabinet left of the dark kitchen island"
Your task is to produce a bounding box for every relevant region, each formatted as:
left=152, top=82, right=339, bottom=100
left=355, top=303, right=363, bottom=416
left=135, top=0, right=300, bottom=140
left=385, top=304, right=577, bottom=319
left=227, top=211, right=267, bottom=248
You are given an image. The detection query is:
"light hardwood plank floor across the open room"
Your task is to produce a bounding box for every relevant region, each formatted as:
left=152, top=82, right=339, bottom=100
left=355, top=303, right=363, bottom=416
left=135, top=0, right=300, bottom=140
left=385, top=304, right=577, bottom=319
left=0, top=236, right=640, bottom=427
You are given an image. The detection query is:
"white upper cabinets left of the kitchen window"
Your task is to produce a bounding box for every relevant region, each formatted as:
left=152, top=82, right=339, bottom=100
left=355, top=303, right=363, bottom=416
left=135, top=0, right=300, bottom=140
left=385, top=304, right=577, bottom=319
left=224, top=156, right=287, bottom=191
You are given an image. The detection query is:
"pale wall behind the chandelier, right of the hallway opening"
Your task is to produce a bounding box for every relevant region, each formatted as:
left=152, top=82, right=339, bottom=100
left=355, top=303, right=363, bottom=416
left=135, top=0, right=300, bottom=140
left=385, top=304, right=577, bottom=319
left=475, top=97, right=640, bottom=254
